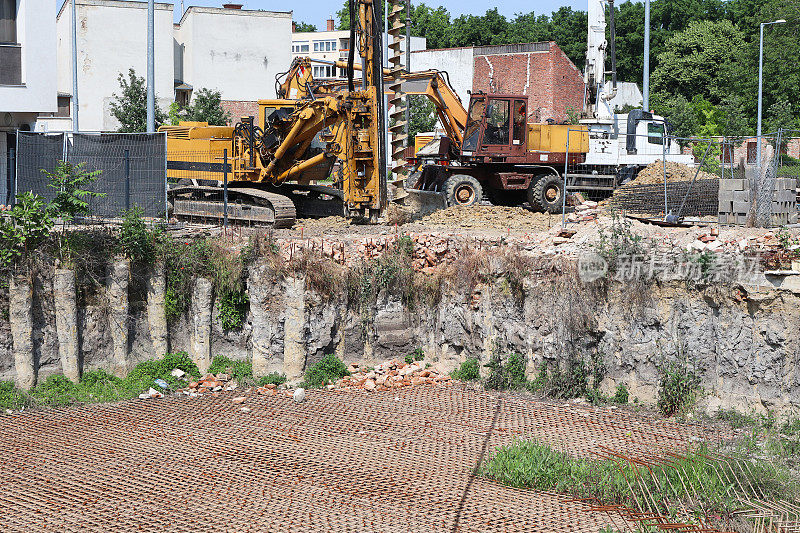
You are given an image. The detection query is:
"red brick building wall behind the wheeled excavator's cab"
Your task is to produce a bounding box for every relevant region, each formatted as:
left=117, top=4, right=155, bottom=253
left=472, top=42, right=583, bottom=122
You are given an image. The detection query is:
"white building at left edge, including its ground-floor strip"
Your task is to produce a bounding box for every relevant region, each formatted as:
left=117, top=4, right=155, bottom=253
left=0, top=0, right=58, bottom=204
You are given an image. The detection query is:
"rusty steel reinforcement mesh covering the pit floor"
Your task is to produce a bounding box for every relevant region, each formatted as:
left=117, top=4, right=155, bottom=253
left=0, top=385, right=715, bottom=533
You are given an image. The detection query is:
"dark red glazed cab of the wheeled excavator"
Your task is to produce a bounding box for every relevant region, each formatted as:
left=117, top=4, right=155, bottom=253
left=461, top=93, right=528, bottom=158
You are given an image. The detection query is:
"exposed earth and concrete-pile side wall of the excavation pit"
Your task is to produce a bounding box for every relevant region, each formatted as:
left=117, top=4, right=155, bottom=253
left=0, top=260, right=800, bottom=416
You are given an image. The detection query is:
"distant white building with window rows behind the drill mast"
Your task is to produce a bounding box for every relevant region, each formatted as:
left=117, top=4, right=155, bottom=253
left=292, top=19, right=426, bottom=79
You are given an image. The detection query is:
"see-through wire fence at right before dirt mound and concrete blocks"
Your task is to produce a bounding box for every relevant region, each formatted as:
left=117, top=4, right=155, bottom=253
left=563, top=128, right=800, bottom=227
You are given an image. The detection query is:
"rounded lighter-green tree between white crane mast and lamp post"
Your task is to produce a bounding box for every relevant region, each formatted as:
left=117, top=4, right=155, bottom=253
left=652, top=20, right=744, bottom=105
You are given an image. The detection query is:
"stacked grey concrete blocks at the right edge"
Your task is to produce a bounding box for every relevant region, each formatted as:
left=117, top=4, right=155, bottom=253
left=719, top=178, right=797, bottom=226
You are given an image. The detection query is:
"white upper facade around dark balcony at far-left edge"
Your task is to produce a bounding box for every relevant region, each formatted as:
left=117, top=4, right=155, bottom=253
left=0, top=0, right=58, bottom=118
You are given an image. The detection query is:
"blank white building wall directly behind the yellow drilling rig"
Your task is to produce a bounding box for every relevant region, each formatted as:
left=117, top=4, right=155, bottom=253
left=175, top=7, right=292, bottom=101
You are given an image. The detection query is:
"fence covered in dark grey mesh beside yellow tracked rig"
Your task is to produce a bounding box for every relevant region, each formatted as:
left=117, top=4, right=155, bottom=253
left=14, top=132, right=167, bottom=218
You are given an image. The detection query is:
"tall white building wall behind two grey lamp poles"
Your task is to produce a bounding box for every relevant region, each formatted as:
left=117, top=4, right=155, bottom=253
left=54, top=0, right=174, bottom=131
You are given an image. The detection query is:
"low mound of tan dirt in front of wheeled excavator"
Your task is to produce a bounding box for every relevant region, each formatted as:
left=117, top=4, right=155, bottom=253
left=420, top=205, right=553, bottom=230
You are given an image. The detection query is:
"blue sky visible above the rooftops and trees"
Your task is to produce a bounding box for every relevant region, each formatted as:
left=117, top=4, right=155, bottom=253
left=56, top=0, right=586, bottom=30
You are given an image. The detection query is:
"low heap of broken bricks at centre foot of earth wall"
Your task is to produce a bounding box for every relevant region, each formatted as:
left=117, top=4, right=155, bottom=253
left=328, top=360, right=451, bottom=392
